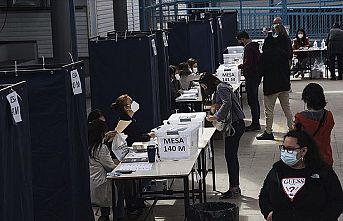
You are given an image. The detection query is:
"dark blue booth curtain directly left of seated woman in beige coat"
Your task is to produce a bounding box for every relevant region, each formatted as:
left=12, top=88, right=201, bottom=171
left=0, top=68, right=94, bottom=221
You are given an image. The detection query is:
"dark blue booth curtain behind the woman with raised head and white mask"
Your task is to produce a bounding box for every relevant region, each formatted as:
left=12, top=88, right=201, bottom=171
left=89, top=35, right=161, bottom=132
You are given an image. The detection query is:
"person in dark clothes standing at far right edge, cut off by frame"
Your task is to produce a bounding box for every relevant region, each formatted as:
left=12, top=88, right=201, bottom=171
left=327, top=23, right=343, bottom=80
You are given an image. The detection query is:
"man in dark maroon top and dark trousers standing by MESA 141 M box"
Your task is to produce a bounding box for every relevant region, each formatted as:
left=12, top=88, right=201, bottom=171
left=237, top=31, right=261, bottom=131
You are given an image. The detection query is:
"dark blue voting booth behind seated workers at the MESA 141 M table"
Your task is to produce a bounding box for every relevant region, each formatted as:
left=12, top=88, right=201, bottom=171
left=168, top=19, right=216, bottom=72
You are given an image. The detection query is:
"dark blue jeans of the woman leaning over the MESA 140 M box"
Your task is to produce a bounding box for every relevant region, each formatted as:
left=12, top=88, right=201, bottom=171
left=225, top=120, right=245, bottom=187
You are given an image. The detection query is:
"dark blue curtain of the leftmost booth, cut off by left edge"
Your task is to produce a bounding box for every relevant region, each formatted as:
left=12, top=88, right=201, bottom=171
left=0, top=82, right=34, bottom=221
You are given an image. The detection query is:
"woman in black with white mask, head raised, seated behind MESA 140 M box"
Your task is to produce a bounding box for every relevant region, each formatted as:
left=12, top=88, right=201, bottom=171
left=112, top=94, right=155, bottom=146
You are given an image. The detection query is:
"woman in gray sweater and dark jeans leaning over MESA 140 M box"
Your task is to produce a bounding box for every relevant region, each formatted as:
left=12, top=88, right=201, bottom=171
left=199, top=74, right=245, bottom=199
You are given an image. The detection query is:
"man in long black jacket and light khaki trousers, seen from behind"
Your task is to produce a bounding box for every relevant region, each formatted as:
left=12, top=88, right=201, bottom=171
left=256, top=35, right=293, bottom=140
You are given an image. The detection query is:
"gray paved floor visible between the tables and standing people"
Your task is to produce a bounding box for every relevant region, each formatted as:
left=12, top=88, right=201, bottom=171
left=91, top=77, right=343, bottom=221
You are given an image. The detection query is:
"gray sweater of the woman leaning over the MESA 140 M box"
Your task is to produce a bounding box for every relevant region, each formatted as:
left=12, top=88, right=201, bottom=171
left=214, top=83, right=245, bottom=122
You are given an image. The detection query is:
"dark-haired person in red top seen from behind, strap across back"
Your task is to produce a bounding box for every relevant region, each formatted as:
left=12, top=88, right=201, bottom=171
left=295, top=83, right=335, bottom=166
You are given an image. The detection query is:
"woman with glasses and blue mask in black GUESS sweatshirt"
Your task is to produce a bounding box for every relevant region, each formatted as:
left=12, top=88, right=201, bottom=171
left=259, top=129, right=343, bottom=221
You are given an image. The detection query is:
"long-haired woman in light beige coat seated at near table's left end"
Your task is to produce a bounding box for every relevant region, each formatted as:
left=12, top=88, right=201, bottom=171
left=88, top=119, right=116, bottom=221
